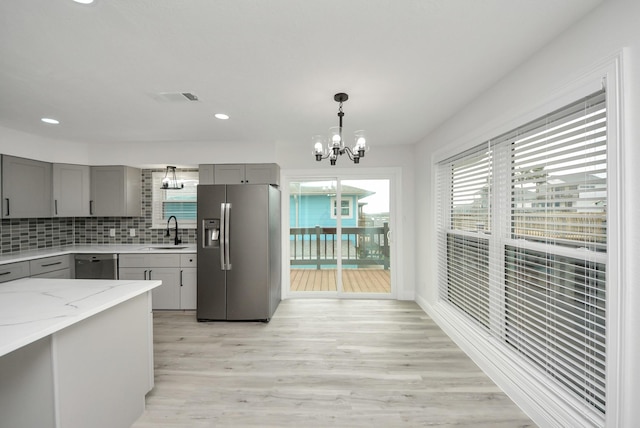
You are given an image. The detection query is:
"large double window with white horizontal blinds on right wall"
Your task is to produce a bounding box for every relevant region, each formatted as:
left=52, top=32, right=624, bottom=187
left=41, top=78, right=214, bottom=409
left=437, top=91, right=607, bottom=424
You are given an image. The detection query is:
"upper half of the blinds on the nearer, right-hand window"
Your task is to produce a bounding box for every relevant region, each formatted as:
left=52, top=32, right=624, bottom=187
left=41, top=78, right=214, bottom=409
left=511, top=93, right=607, bottom=251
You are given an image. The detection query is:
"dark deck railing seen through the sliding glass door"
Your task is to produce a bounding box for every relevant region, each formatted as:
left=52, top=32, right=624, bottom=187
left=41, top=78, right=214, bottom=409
left=290, top=223, right=389, bottom=269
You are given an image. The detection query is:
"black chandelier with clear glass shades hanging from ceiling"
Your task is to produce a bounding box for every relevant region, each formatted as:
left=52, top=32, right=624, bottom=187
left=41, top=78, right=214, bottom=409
left=313, top=92, right=368, bottom=165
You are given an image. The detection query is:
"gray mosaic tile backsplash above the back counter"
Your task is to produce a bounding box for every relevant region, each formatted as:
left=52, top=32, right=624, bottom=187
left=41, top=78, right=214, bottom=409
left=0, top=169, right=197, bottom=254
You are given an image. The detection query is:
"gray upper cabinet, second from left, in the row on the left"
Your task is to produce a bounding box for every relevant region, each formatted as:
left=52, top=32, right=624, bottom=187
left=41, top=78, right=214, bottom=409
left=53, top=163, right=91, bottom=217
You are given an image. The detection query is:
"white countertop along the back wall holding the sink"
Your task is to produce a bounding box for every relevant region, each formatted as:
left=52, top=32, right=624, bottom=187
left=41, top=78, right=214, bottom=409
left=0, top=244, right=196, bottom=264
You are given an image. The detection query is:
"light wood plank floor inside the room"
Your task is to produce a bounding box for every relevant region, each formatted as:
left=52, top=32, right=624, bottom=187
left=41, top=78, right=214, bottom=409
left=133, top=299, right=534, bottom=428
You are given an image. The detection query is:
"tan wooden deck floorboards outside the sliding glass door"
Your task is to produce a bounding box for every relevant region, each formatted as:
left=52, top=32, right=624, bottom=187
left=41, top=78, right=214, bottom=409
left=291, top=268, right=391, bottom=294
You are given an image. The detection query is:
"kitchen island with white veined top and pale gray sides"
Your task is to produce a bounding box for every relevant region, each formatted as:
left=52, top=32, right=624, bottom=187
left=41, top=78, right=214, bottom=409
left=0, top=278, right=161, bottom=428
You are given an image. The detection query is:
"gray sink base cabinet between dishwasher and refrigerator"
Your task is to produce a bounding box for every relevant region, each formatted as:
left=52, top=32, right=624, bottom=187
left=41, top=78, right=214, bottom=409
left=118, top=253, right=196, bottom=310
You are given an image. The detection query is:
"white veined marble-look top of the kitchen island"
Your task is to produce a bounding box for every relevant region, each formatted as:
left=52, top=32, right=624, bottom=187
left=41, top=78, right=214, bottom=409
left=0, top=278, right=162, bottom=357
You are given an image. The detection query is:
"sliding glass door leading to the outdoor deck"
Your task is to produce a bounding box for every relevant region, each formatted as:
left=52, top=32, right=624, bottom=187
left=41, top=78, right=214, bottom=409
left=288, top=179, right=392, bottom=297
